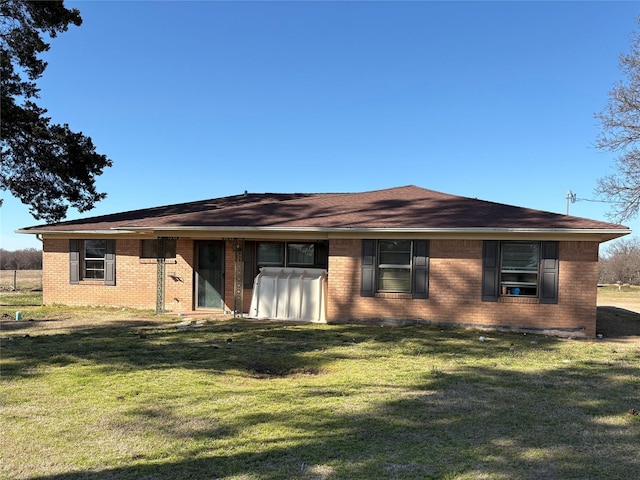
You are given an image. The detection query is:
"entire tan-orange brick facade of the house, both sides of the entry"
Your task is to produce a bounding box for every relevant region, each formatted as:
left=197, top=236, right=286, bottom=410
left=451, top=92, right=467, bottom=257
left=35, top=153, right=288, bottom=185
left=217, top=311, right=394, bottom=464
left=43, top=239, right=598, bottom=336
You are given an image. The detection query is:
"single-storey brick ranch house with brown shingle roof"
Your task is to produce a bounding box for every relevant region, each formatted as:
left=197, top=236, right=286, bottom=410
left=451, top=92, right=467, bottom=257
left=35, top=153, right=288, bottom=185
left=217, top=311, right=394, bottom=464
left=18, top=186, right=630, bottom=337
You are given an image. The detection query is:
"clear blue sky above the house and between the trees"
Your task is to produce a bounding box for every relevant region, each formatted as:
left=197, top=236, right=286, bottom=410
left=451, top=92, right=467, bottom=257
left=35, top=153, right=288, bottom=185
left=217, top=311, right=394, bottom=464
left=0, top=1, right=640, bottom=250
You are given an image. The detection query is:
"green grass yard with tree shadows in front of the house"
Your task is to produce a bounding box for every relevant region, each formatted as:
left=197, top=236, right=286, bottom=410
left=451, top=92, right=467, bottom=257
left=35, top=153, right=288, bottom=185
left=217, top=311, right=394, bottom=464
left=0, top=294, right=640, bottom=480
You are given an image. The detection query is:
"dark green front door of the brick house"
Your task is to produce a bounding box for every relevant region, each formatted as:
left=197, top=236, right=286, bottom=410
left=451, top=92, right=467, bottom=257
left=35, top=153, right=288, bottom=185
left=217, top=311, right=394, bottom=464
left=196, top=241, right=224, bottom=308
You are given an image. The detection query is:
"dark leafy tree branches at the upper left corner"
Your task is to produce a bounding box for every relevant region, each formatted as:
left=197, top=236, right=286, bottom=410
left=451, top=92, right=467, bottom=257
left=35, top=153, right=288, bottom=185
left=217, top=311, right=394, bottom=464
left=0, top=0, right=112, bottom=222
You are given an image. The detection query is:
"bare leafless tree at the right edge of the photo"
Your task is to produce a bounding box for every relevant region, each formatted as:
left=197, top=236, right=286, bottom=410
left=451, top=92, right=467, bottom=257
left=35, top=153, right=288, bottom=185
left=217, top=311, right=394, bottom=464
left=596, top=17, right=640, bottom=222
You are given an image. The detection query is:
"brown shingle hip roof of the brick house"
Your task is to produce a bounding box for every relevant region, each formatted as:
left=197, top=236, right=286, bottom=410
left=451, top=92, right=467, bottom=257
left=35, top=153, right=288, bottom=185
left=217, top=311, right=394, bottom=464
left=21, top=185, right=628, bottom=233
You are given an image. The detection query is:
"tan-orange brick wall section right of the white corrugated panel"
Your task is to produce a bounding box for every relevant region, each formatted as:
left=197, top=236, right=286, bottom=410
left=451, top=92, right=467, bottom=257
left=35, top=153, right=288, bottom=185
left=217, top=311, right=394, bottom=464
left=327, top=240, right=598, bottom=336
